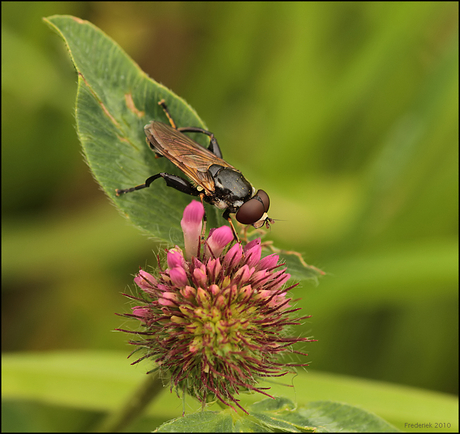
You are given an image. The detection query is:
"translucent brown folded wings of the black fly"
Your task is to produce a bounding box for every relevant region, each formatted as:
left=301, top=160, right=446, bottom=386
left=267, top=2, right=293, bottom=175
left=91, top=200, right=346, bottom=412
left=145, top=121, right=236, bottom=194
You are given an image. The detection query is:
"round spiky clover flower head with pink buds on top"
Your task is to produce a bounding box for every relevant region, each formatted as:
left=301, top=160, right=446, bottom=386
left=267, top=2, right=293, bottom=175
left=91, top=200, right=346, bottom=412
left=117, top=201, right=311, bottom=411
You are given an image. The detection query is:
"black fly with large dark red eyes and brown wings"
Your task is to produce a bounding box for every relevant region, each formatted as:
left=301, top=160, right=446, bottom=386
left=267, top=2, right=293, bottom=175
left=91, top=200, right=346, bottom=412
left=116, top=100, right=273, bottom=239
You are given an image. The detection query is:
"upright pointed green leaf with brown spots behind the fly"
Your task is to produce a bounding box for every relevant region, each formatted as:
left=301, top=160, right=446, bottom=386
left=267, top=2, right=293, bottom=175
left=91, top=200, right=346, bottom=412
left=45, top=15, right=224, bottom=245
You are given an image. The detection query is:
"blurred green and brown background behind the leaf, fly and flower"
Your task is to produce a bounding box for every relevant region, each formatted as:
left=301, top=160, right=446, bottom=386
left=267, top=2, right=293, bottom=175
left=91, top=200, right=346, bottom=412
left=2, top=2, right=458, bottom=410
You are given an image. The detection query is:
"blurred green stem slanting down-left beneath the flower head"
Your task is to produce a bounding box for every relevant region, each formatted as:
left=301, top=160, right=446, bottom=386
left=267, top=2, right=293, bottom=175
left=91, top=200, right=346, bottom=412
left=95, top=373, right=163, bottom=432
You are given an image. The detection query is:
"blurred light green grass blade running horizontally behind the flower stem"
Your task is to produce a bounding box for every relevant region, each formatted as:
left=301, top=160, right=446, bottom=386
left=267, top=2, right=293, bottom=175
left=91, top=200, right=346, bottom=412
left=2, top=351, right=458, bottom=432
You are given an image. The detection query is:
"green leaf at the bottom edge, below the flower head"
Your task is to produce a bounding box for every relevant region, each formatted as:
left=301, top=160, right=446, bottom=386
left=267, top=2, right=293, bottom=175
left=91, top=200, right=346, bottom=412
left=158, top=398, right=398, bottom=432
